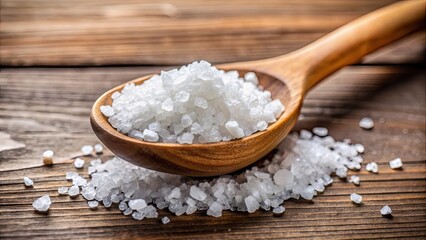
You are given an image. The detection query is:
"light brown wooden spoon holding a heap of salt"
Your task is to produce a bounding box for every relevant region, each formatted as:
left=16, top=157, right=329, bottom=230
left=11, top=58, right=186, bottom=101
left=90, top=0, right=425, bottom=176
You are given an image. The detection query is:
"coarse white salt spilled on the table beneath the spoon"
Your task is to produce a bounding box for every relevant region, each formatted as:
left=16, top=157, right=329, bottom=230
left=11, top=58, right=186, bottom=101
left=58, top=130, right=366, bottom=220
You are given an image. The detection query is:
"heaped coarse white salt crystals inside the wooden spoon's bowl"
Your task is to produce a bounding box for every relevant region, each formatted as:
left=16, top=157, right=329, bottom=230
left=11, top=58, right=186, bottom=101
left=100, top=61, right=284, bottom=144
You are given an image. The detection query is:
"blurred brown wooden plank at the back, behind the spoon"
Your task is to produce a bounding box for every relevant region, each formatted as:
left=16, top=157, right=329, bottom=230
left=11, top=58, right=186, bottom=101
left=0, top=0, right=412, bottom=66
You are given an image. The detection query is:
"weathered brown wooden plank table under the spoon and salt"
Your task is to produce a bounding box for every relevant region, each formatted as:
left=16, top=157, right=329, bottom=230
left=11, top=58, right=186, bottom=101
left=0, top=0, right=426, bottom=239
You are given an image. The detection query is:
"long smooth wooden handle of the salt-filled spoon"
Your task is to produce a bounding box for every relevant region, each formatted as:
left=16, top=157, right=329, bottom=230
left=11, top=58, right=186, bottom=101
left=293, top=0, right=426, bottom=93
